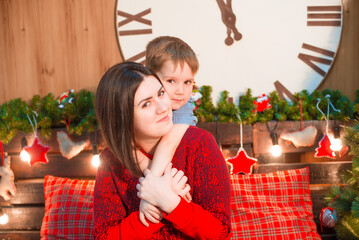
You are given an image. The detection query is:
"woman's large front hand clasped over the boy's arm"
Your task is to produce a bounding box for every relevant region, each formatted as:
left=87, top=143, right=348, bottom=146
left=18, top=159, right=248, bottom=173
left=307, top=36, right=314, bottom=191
left=136, top=163, right=181, bottom=214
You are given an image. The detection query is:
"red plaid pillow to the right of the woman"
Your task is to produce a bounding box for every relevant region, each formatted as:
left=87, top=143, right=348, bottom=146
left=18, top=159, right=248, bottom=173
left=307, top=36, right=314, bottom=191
left=231, top=168, right=321, bottom=240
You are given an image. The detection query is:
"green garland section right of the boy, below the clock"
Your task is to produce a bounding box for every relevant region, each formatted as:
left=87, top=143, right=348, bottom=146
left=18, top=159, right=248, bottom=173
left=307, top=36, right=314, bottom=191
left=195, top=86, right=359, bottom=124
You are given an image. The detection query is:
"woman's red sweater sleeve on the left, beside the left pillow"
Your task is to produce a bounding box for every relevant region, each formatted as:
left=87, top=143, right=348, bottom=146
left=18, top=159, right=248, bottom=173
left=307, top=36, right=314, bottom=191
left=94, top=149, right=163, bottom=240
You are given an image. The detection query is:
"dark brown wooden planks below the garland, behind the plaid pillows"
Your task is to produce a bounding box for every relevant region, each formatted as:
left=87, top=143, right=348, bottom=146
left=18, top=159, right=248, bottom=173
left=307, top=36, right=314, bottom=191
left=0, top=121, right=351, bottom=240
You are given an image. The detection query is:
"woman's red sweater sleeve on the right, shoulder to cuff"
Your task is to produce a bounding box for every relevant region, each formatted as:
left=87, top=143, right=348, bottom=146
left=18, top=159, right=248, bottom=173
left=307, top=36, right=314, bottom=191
left=165, top=127, right=231, bottom=239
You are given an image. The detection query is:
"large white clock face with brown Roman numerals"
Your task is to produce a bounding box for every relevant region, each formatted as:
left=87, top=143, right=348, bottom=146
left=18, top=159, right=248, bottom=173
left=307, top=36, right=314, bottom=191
left=115, top=0, right=342, bottom=100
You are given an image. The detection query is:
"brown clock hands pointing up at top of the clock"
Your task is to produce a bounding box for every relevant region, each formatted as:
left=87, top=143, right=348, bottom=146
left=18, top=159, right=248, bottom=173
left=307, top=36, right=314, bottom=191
left=216, top=0, right=242, bottom=46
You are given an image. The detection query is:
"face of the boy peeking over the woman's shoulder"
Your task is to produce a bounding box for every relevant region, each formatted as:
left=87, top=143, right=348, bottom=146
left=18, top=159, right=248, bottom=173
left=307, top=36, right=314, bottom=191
left=157, top=60, right=194, bottom=110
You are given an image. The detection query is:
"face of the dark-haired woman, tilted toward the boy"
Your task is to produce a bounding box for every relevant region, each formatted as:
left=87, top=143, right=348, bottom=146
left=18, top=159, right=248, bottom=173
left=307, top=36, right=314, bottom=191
left=134, top=76, right=173, bottom=142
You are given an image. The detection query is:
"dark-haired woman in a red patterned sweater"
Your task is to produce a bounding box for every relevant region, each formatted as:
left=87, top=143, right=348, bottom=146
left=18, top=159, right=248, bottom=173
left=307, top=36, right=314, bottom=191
left=94, top=62, right=230, bottom=239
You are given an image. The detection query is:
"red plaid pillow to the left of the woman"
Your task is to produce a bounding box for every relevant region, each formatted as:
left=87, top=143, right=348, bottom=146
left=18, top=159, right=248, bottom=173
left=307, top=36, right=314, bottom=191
left=41, top=175, right=95, bottom=239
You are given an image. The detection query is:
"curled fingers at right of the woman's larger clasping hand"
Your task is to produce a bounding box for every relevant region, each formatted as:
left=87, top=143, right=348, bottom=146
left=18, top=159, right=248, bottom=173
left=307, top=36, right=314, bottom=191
left=171, top=168, right=192, bottom=202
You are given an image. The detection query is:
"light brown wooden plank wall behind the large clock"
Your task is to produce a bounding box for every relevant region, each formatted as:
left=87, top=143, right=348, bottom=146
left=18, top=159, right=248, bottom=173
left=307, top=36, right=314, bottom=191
left=0, top=0, right=359, bottom=104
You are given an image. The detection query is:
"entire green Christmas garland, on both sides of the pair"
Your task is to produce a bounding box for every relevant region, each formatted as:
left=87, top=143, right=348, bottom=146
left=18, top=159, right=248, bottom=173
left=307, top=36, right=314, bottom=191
left=0, top=86, right=359, bottom=144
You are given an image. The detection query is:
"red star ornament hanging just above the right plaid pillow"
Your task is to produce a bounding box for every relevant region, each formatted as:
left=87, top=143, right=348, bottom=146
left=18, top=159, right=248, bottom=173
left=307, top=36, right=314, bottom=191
left=226, top=148, right=258, bottom=174
